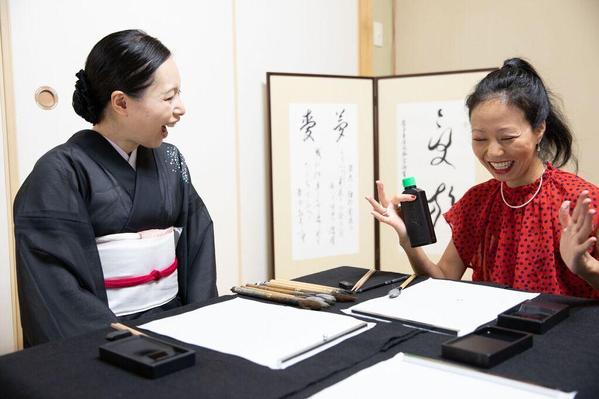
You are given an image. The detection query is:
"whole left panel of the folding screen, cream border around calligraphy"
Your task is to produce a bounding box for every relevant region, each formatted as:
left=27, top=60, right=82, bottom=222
left=267, top=73, right=376, bottom=278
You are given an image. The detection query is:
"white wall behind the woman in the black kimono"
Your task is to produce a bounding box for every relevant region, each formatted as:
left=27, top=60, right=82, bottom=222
left=0, top=0, right=358, bottom=352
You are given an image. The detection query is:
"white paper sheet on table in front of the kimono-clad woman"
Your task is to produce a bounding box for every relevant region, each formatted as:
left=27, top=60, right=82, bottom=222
left=140, top=298, right=374, bottom=369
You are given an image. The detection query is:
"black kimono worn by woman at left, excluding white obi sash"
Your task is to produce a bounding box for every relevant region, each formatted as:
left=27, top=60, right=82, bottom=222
left=14, top=130, right=217, bottom=346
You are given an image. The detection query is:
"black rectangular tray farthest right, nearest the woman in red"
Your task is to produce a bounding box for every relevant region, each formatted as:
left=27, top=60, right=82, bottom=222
left=497, top=300, right=570, bottom=334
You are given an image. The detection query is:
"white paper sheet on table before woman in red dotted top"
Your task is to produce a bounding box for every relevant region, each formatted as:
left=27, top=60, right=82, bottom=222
left=350, top=278, right=539, bottom=336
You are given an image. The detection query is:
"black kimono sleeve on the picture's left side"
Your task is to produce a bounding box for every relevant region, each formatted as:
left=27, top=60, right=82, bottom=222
left=14, top=153, right=116, bottom=346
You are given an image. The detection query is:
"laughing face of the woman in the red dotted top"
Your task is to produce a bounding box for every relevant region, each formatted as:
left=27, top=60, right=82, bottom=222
left=470, top=97, right=545, bottom=187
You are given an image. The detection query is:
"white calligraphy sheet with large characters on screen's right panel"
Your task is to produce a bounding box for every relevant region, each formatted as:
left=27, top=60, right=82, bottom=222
left=396, top=99, right=475, bottom=253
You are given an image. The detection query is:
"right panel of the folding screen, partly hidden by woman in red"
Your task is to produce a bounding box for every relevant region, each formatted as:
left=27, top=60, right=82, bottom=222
left=377, top=69, right=493, bottom=273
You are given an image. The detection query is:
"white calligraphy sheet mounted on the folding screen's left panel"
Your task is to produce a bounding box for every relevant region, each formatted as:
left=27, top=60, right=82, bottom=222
left=289, top=104, right=360, bottom=260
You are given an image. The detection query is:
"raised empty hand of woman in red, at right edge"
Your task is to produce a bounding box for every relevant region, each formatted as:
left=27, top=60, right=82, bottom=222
left=559, top=190, right=599, bottom=280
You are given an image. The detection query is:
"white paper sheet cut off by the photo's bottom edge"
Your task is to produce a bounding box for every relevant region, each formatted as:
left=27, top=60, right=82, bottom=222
left=312, top=353, right=576, bottom=399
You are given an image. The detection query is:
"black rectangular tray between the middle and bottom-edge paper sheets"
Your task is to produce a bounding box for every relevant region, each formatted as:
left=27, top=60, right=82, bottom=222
left=441, top=327, right=532, bottom=368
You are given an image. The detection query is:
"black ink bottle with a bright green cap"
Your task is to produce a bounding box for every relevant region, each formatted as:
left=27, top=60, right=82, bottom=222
left=401, top=177, right=437, bottom=248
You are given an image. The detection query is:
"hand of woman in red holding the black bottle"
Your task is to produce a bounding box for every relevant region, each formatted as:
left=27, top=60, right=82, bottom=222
left=366, top=180, right=416, bottom=246
